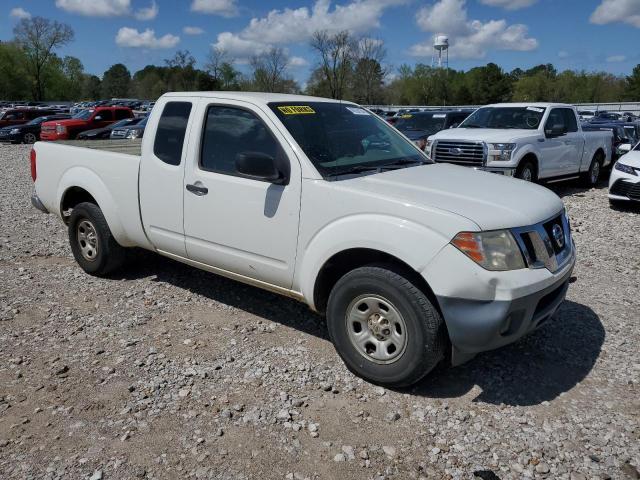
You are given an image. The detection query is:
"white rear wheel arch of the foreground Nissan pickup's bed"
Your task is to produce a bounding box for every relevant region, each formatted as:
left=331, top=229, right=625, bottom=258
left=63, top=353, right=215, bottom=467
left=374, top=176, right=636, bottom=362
left=56, top=166, right=137, bottom=247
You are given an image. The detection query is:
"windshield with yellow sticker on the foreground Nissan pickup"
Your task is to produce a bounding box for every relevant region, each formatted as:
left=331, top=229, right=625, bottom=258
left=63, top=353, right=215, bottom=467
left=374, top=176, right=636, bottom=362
left=269, top=102, right=429, bottom=177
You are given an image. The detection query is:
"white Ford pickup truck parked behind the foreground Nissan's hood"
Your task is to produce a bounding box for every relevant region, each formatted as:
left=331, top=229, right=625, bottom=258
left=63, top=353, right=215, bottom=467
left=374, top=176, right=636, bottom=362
left=427, top=103, right=613, bottom=186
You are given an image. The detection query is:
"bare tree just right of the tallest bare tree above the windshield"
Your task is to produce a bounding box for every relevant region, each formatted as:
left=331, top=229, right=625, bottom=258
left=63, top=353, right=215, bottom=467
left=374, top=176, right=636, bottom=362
left=353, top=38, right=389, bottom=105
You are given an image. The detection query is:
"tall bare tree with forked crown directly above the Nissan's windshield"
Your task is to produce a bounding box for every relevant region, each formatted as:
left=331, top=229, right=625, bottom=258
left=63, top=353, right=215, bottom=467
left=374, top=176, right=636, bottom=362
left=311, top=30, right=354, bottom=100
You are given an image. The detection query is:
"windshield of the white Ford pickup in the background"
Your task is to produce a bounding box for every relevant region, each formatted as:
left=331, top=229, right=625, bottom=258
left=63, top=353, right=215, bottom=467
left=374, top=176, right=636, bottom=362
left=460, top=107, right=546, bottom=130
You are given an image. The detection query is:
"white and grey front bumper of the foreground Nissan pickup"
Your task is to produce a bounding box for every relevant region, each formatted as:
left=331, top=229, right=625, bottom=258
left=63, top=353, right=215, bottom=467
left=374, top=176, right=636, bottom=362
left=423, top=240, right=576, bottom=365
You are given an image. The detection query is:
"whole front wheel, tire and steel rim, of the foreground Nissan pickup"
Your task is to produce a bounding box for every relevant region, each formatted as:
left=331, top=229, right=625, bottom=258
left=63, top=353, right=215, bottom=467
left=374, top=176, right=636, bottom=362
left=327, top=266, right=447, bottom=387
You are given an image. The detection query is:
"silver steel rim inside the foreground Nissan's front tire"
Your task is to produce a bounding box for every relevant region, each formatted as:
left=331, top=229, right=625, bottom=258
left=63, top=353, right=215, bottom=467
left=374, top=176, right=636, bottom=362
left=345, top=295, right=407, bottom=364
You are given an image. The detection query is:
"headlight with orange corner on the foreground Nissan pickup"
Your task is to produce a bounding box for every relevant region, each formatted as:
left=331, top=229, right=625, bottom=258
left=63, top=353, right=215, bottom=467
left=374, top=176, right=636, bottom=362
left=451, top=230, right=525, bottom=271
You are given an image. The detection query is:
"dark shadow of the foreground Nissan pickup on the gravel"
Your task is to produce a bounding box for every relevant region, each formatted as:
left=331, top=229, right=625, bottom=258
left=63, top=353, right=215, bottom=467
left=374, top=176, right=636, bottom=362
left=117, top=251, right=605, bottom=406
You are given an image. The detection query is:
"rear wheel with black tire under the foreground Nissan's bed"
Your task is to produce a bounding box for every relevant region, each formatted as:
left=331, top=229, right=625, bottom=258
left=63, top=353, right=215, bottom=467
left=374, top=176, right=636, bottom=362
left=69, top=202, right=126, bottom=277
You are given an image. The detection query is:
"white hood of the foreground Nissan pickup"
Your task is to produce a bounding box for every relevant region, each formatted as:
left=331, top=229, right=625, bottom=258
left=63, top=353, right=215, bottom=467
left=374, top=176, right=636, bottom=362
left=343, top=164, right=563, bottom=230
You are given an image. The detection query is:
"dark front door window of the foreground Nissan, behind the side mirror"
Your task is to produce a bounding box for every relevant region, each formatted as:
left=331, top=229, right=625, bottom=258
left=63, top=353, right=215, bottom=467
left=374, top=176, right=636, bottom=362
left=200, top=106, right=280, bottom=175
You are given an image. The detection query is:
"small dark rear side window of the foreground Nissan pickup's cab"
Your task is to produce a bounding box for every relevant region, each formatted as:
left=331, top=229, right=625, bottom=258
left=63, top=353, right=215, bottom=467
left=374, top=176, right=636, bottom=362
left=153, top=102, right=191, bottom=165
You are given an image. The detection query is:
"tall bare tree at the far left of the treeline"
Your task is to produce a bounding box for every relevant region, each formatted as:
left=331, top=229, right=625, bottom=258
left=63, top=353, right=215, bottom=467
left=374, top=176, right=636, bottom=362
left=13, top=17, right=74, bottom=100
